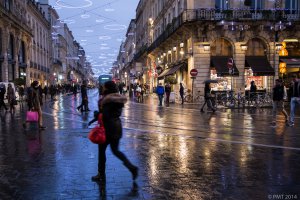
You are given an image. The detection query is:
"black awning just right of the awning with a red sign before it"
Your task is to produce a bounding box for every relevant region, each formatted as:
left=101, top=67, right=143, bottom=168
left=246, top=56, right=275, bottom=76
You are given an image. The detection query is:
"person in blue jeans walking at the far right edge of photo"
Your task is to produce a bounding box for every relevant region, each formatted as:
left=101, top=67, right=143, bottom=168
left=288, top=74, right=300, bottom=126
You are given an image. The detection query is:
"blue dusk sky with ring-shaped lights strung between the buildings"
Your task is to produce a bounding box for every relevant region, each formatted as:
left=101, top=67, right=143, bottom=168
left=49, top=0, right=139, bottom=75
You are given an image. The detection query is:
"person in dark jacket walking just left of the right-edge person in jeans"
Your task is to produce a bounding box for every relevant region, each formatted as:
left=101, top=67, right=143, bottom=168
left=272, top=79, right=288, bottom=126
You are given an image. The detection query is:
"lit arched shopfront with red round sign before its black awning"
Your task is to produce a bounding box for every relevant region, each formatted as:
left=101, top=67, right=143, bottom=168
left=210, top=38, right=239, bottom=91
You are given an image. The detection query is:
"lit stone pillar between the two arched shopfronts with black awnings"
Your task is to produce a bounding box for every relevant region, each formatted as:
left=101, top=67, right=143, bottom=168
left=233, top=42, right=246, bottom=93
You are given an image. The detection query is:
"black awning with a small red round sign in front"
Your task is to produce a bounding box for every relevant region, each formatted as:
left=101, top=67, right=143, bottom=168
left=211, top=56, right=239, bottom=76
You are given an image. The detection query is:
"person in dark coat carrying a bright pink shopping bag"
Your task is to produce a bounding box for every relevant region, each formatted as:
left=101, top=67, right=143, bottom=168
left=27, top=81, right=46, bottom=130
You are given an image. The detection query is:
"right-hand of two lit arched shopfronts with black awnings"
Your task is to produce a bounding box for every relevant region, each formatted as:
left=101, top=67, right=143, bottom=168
left=244, top=38, right=275, bottom=90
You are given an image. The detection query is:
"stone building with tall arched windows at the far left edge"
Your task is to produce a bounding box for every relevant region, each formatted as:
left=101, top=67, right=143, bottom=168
left=0, top=0, right=33, bottom=82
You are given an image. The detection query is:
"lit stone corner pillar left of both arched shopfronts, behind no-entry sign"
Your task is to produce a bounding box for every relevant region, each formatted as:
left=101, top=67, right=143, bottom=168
left=193, top=42, right=210, bottom=95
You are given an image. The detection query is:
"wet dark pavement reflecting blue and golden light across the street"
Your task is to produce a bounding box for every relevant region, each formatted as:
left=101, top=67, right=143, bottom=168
left=0, top=90, right=300, bottom=200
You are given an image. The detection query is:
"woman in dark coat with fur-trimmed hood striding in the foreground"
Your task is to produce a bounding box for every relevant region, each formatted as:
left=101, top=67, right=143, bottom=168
left=92, top=81, right=138, bottom=182
